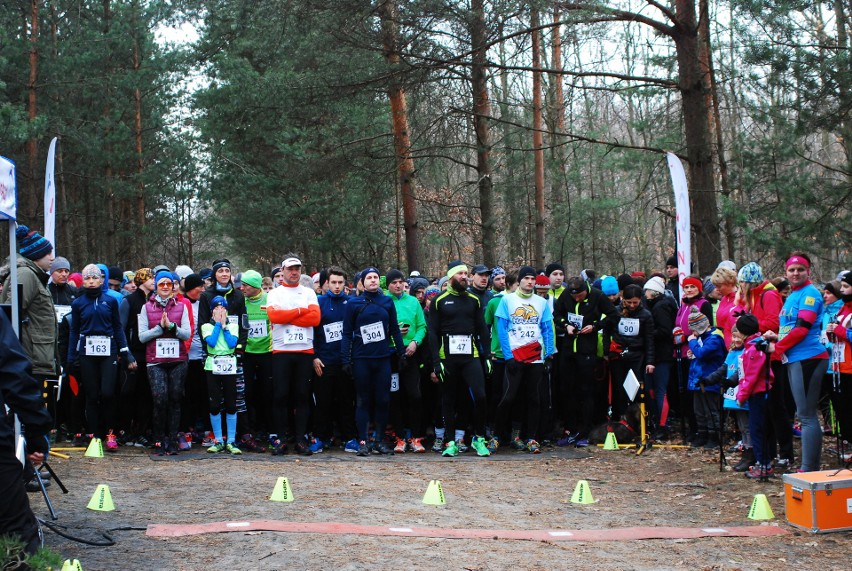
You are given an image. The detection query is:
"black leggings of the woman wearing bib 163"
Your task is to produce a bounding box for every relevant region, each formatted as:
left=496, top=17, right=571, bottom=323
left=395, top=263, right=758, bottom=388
left=80, top=355, right=118, bottom=438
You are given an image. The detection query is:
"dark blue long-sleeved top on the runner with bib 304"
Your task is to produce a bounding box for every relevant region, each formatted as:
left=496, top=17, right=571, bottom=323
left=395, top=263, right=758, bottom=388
left=340, top=291, right=405, bottom=365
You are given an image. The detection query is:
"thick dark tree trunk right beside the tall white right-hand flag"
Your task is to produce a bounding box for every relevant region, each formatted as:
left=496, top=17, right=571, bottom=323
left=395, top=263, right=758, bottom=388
left=673, top=0, right=721, bottom=273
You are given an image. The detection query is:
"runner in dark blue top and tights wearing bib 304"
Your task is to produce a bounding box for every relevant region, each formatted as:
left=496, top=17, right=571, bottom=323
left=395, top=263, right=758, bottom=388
left=341, top=267, right=405, bottom=456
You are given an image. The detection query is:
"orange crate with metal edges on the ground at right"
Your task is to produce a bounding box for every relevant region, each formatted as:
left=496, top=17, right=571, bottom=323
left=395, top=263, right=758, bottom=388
left=784, top=470, right=852, bottom=533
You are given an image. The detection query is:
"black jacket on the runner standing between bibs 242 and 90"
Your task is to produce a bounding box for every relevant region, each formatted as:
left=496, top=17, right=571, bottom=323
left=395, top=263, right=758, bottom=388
left=553, top=286, right=615, bottom=355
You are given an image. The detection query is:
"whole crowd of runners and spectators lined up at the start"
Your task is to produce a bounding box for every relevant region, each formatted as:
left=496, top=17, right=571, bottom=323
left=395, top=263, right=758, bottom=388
left=0, top=226, right=852, bottom=478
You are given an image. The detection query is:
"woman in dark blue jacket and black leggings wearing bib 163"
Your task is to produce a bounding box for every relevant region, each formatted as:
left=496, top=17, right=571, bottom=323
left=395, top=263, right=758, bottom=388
left=68, top=264, right=136, bottom=451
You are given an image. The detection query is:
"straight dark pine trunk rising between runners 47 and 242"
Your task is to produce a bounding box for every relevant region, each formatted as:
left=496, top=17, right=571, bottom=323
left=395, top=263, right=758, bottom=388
left=470, top=0, right=497, bottom=268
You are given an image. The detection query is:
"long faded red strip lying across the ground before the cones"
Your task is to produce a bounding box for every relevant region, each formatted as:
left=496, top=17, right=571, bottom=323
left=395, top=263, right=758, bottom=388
left=146, top=520, right=787, bottom=541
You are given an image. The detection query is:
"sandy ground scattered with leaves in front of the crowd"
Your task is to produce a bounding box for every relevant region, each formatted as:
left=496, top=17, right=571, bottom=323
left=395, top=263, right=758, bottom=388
left=30, top=442, right=852, bottom=571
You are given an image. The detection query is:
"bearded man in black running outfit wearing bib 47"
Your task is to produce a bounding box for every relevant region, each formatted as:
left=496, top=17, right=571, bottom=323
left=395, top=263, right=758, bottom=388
left=427, top=262, right=491, bottom=456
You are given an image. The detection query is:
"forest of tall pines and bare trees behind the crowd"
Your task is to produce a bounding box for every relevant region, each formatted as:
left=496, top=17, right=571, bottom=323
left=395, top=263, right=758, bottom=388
left=0, top=0, right=852, bottom=279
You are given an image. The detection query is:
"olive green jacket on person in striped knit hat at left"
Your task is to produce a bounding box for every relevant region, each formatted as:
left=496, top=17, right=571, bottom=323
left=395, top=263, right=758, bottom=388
left=0, top=256, right=59, bottom=379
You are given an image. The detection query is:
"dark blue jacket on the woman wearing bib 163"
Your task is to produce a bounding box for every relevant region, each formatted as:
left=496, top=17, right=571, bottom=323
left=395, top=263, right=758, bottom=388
left=68, top=290, right=127, bottom=363
